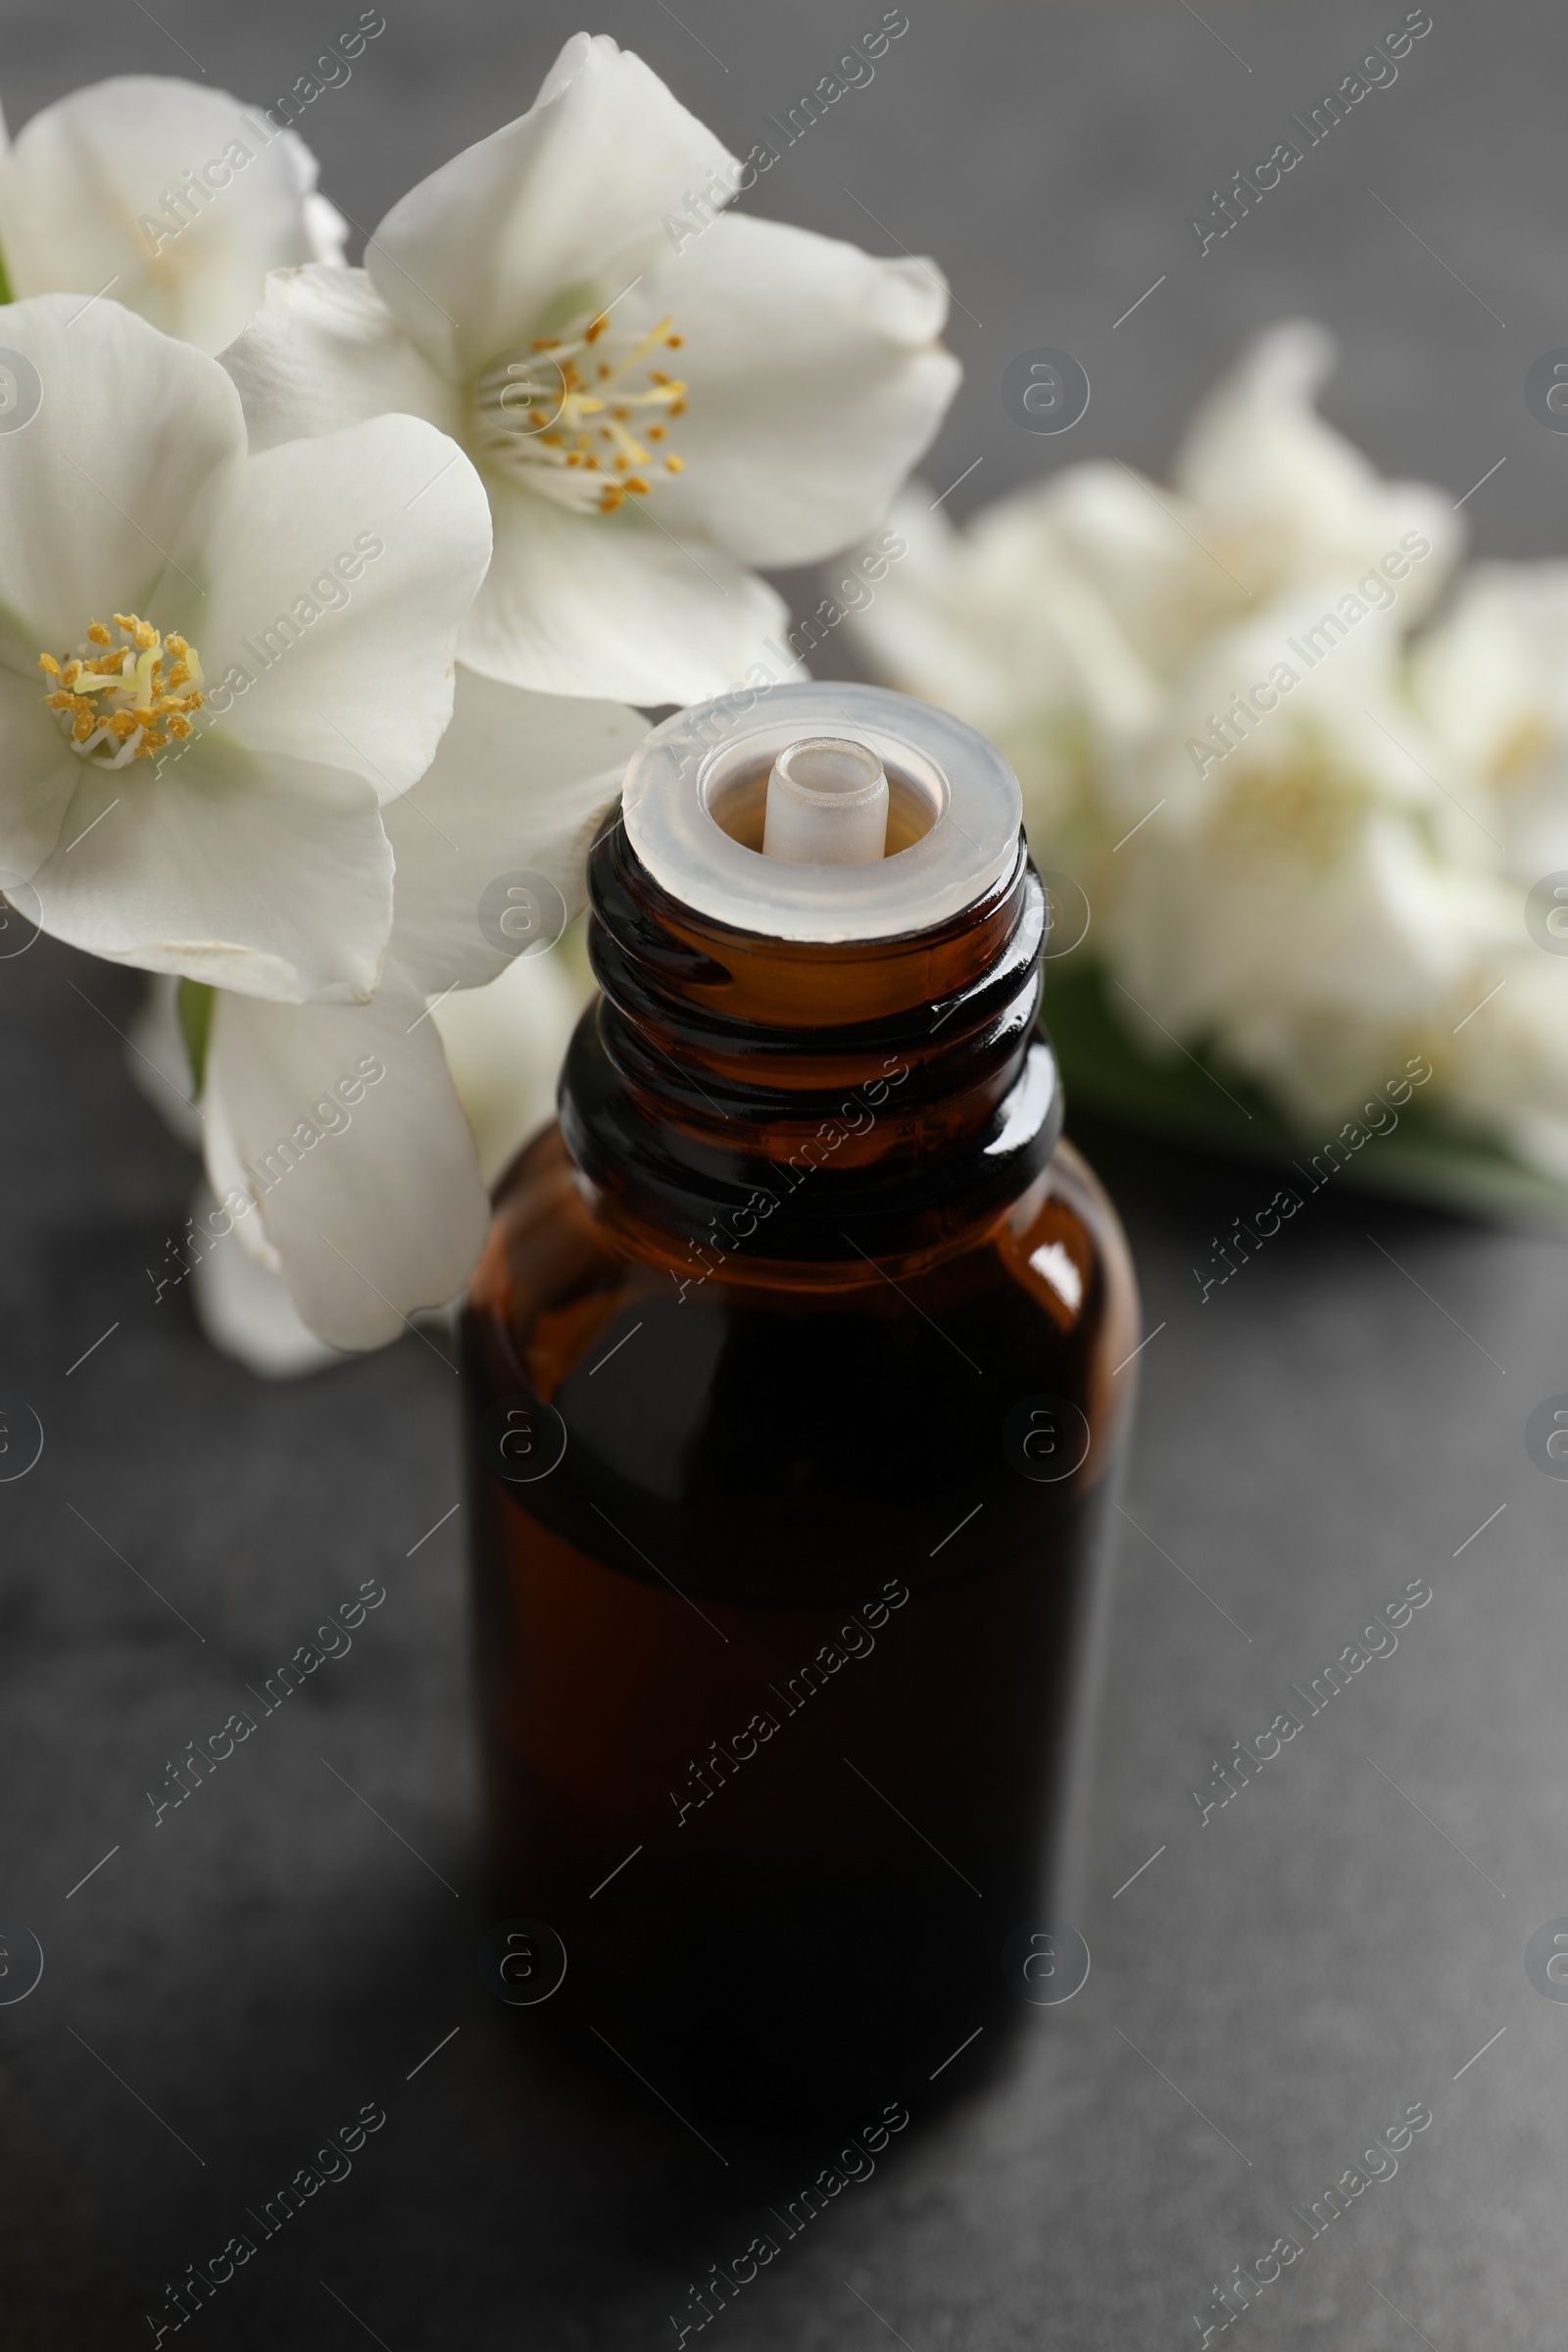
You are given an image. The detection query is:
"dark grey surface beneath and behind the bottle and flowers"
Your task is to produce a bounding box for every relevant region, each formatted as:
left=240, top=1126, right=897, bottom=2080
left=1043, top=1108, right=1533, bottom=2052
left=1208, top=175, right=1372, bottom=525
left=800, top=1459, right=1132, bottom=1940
left=0, top=0, right=1568, bottom=2352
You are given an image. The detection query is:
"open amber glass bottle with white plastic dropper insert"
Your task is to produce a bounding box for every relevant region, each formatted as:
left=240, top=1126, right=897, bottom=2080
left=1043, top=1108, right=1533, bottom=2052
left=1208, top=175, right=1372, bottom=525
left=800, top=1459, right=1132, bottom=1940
left=466, top=687, right=1138, bottom=2124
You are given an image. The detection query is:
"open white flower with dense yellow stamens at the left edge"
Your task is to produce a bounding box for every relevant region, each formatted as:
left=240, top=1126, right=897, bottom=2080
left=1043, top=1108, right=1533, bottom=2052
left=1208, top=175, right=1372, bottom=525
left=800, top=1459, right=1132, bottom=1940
left=0, top=294, right=489, bottom=1002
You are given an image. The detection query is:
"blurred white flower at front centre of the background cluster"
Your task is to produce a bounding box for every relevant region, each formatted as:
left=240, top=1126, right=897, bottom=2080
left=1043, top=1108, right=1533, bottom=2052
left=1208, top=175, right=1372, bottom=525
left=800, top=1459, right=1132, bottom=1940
left=1101, top=590, right=1507, bottom=1122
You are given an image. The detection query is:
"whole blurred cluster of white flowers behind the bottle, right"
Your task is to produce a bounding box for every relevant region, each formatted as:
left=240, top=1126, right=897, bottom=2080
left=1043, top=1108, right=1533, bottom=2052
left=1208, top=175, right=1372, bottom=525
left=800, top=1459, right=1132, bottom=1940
left=851, top=324, right=1568, bottom=1176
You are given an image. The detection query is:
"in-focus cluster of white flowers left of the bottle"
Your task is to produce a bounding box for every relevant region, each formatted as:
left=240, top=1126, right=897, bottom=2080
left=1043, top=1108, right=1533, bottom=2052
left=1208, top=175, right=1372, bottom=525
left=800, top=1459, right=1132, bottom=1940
left=0, top=33, right=956, bottom=1364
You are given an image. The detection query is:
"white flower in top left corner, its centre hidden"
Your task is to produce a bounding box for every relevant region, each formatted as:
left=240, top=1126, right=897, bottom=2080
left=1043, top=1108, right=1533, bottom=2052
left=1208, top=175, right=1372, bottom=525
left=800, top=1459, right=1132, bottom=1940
left=0, top=73, right=348, bottom=353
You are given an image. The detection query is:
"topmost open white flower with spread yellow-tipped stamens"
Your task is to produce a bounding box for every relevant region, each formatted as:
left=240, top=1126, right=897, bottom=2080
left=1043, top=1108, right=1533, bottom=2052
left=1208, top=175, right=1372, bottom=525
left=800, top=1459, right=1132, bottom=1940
left=225, top=33, right=956, bottom=704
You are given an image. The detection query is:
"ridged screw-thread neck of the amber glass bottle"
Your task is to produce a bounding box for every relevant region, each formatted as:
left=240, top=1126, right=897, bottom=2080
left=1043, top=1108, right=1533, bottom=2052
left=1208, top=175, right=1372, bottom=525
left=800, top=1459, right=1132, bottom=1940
left=562, top=821, right=1062, bottom=1272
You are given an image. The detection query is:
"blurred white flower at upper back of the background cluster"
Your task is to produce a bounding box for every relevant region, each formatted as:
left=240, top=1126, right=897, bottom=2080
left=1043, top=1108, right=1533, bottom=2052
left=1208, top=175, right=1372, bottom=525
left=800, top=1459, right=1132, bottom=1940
left=851, top=322, right=1460, bottom=882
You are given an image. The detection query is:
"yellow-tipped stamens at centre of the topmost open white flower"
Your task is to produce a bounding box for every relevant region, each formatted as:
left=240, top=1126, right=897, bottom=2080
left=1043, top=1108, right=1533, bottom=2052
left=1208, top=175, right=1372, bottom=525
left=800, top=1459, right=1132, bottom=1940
left=472, top=311, right=686, bottom=515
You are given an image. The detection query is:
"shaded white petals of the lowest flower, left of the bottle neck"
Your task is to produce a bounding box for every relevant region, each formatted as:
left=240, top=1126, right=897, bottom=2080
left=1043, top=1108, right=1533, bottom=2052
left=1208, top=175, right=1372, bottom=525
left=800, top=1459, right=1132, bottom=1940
left=136, top=670, right=647, bottom=1348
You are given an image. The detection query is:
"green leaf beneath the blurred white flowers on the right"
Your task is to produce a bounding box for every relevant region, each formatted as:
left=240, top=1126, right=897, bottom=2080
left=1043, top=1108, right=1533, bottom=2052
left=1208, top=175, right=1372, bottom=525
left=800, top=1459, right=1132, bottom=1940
left=1042, top=957, right=1568, bottom=1230
